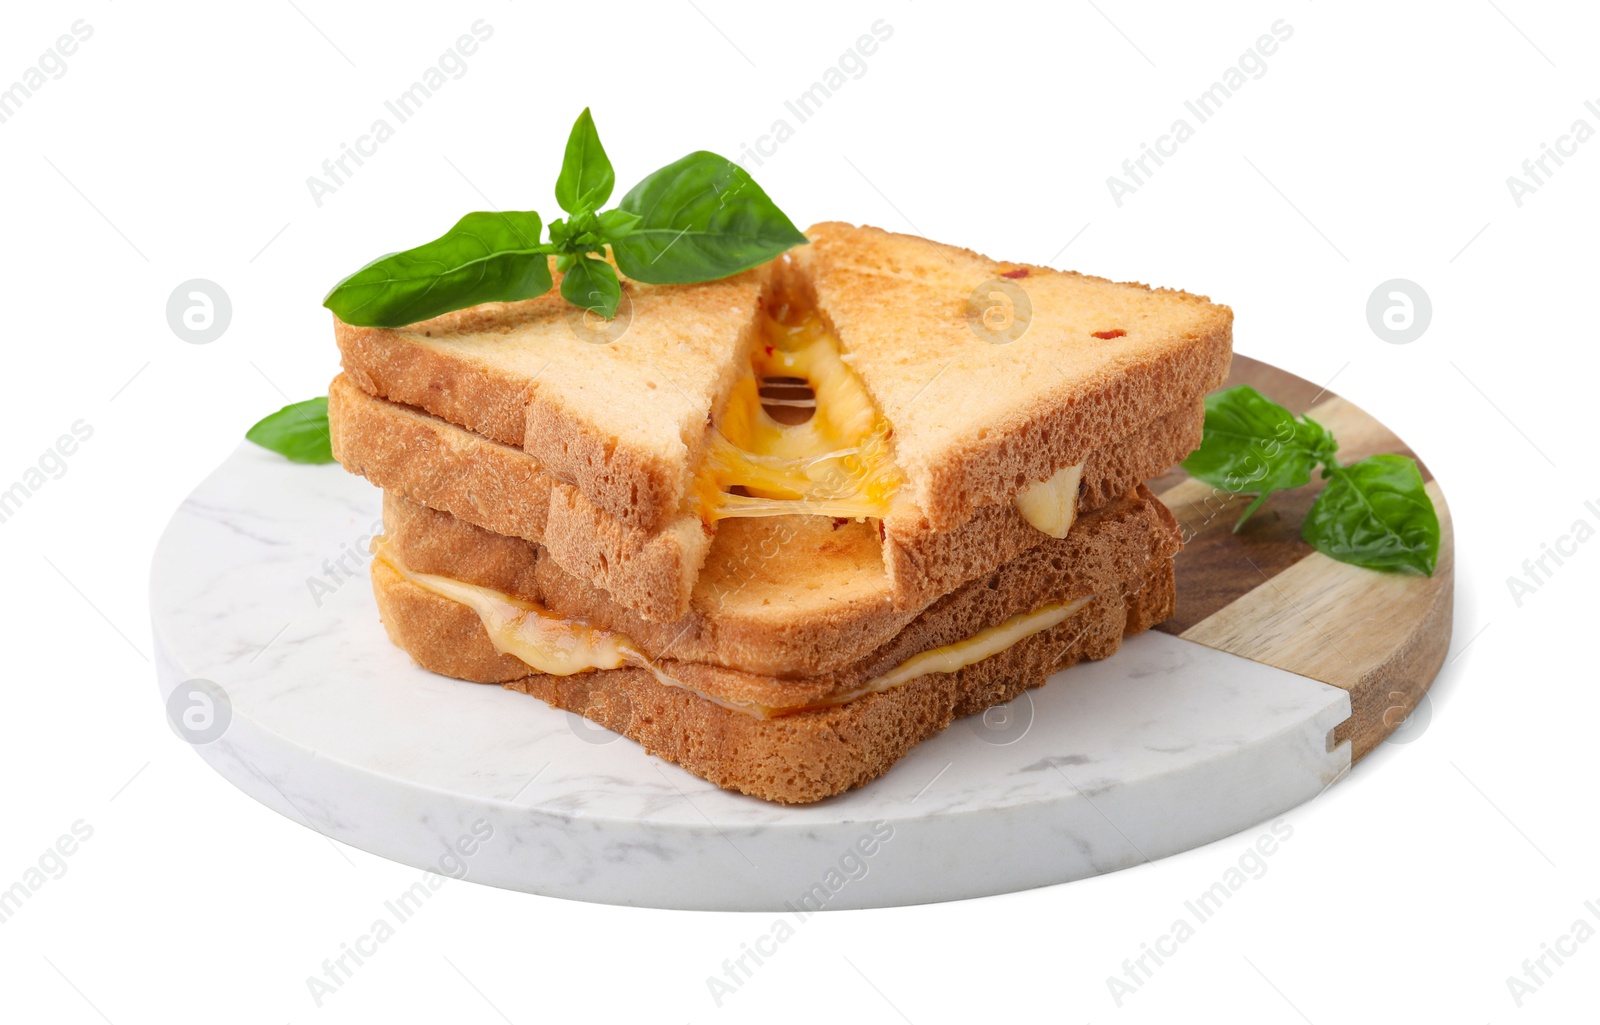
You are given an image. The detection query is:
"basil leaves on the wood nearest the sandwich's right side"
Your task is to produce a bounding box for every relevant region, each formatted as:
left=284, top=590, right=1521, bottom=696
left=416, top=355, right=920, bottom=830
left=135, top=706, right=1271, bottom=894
left=1184, top=385, right=1339, bottom=531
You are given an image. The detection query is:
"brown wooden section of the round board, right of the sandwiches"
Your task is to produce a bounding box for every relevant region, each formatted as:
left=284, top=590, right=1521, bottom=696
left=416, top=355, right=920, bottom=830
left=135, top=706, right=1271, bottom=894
left=1150, top=355, right=1456, bottom=760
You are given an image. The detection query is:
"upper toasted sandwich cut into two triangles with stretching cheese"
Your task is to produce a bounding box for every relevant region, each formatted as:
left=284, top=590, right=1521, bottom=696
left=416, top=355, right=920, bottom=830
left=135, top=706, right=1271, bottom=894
left=333, top=224, right=1232, bottom=622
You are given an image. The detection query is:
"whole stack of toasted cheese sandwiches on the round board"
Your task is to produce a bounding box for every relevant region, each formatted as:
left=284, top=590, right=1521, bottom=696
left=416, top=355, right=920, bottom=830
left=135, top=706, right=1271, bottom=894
left=330, top=224, right=1232, bottom=803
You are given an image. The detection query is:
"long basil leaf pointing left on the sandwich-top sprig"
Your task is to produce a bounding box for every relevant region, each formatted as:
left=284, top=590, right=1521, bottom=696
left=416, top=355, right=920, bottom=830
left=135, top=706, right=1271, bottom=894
left=323, top=209, right=554, bottom=328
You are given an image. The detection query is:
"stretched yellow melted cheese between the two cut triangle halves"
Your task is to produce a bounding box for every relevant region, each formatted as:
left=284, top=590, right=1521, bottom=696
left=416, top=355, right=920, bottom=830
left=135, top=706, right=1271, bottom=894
left=696, top=307, right=901, bottom=523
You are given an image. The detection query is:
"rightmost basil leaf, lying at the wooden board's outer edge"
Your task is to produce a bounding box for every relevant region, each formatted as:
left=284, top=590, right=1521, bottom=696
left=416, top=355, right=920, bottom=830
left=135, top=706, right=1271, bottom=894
left=1301, top=456, right=1438, bottom=576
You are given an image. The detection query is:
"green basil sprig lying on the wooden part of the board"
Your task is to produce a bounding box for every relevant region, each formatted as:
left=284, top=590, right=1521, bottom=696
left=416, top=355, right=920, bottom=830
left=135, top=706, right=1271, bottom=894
left=1184, top=385, right=1438, bottom=576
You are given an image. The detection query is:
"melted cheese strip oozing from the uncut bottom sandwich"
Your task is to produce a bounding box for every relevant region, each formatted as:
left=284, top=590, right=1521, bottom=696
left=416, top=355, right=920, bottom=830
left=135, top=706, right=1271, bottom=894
left=373, top=537, right=1091, bottom=720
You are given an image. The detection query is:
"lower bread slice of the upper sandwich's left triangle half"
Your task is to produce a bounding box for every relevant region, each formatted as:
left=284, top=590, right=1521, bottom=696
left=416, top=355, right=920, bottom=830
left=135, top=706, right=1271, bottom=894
left=328, top=374, right=710, bottom=619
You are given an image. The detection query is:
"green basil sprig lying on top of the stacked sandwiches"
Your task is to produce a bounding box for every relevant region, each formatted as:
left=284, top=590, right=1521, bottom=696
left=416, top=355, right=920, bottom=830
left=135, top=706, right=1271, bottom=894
left=323, top=109, right=805, bottom=328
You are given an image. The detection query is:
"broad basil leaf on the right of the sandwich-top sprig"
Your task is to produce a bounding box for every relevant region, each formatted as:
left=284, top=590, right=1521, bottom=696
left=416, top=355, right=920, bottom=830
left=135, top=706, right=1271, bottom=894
left=611, top=150, right=805, bottom=285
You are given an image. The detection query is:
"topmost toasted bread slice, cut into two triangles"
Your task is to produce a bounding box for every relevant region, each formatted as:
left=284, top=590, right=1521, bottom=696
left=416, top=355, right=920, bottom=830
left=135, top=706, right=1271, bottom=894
left=336, top=224, right=1232, bottom=529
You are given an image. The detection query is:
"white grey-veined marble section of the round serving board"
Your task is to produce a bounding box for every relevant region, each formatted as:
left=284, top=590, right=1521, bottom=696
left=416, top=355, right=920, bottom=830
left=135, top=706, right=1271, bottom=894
left=152, top=446, right=1350, bottom=910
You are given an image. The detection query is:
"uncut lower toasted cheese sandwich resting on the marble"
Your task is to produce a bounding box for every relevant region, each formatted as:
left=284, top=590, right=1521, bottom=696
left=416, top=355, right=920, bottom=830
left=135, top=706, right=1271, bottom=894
left=373, top=488, right=1179, bottom=803
